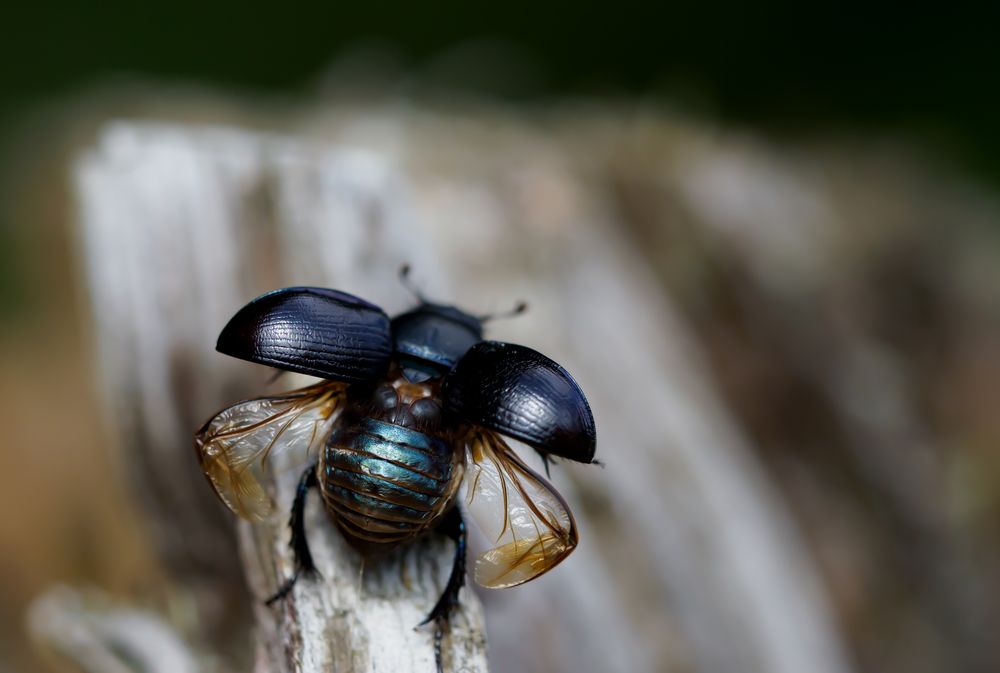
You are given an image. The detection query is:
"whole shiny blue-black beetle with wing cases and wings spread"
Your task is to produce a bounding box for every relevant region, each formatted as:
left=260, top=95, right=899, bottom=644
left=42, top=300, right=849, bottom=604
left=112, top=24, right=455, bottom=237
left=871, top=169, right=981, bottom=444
left=195, top=267, right=596, bottom=673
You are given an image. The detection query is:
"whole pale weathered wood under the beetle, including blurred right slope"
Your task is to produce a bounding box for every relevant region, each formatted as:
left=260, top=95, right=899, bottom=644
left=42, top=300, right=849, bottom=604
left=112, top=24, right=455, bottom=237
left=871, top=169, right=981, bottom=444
left=70, top=115, right=850, bottom=673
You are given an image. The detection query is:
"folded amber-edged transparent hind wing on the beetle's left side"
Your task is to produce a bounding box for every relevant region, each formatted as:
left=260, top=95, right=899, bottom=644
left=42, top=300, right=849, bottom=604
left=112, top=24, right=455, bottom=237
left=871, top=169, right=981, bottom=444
left=194, top=381, right=348, bottom=521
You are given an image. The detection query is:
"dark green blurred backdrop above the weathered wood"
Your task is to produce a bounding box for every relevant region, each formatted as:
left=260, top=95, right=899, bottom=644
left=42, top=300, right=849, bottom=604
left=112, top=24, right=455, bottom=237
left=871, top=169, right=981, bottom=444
left=0, top=0, right=1000, bottom=171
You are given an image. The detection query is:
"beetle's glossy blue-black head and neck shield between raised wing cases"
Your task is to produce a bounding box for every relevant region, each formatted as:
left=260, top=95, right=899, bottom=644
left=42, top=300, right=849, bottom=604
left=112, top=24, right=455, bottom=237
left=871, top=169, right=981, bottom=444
left=392, top=301, right=484, bottom=381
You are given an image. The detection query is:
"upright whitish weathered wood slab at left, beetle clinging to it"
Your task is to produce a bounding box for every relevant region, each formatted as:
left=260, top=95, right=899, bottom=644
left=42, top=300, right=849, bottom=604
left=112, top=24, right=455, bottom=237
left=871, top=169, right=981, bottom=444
left=78, top=124, right=486, bottom=673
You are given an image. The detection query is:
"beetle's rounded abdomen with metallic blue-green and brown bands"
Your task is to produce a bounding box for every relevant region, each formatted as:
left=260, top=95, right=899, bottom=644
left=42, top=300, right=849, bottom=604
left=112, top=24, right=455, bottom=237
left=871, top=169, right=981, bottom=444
left=320, top=418, right=461, bottom=549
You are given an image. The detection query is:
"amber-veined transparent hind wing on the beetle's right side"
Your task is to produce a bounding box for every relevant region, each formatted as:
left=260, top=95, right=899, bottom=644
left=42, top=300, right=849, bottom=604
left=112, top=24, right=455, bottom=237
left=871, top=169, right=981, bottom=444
left=465, top=427, right=578, bottom=589
